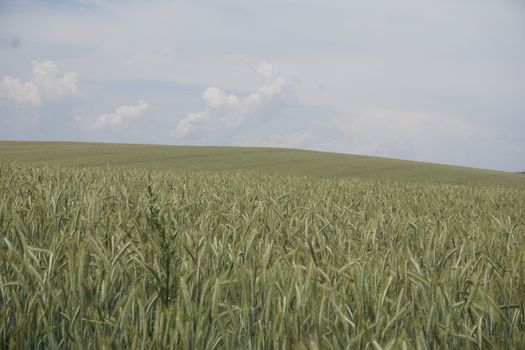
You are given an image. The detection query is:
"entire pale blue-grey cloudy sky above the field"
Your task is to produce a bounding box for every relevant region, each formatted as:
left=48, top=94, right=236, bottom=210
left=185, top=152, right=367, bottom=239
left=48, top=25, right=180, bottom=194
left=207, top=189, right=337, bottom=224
left=0, top=0, right=525, bottom=171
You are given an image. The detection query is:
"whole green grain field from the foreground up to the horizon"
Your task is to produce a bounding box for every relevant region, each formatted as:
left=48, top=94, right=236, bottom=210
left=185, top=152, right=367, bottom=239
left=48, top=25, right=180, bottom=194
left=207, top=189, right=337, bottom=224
left=0, top=142, right=525, bottom=349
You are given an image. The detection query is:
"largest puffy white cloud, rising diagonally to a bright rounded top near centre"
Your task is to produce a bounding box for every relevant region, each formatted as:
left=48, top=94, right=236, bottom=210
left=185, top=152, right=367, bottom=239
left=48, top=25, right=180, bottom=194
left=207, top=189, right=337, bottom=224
left=172, top=62, right=291, bottom=137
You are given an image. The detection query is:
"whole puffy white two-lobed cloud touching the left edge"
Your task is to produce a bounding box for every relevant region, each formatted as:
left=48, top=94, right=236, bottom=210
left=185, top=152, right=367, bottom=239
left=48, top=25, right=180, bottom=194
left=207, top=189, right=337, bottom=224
left=0, top=61, right=78, bottom=106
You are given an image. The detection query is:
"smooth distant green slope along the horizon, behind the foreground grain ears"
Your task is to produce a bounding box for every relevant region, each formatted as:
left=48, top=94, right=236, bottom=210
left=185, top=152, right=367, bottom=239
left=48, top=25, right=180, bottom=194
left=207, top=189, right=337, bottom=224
left=0, top=141, right=525, bottom=189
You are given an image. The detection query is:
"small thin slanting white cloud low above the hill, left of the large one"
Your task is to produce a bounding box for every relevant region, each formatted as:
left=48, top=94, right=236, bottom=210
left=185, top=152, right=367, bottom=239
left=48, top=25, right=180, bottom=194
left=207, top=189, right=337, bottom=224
left=75, top=101, right=149, bottom=130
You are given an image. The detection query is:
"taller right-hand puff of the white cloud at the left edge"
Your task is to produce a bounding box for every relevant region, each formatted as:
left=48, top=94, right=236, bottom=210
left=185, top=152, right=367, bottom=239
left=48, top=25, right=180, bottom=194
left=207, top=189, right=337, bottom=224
left=32, top=60, right=78, bottom=98
